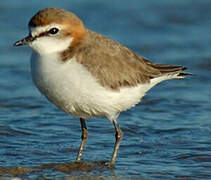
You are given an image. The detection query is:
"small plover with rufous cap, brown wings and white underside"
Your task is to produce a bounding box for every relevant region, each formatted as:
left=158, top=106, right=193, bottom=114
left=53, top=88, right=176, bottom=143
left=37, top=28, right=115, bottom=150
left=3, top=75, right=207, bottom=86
left=14, top=7, right=190, bottom=166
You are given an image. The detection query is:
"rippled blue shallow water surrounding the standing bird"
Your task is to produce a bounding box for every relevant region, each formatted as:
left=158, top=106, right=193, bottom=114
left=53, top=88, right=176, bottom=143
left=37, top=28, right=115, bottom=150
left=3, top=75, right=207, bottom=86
left=0, top=0, right=211, bottom=179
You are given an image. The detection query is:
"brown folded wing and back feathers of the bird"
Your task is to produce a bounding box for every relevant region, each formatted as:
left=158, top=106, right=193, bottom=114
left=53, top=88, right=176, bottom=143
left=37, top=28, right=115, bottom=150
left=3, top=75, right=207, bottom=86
left=61, top=30, right=189, bottom=90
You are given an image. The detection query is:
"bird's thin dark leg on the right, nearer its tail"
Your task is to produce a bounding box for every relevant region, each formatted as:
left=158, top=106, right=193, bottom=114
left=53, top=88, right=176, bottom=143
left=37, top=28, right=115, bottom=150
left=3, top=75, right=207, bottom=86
left=111, top=119, right=123, bottom=166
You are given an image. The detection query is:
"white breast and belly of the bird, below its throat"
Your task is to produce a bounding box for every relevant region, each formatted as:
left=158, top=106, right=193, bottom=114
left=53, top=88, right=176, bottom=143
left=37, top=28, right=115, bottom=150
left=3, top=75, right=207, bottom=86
left=31, top=54, right=151, bottom=121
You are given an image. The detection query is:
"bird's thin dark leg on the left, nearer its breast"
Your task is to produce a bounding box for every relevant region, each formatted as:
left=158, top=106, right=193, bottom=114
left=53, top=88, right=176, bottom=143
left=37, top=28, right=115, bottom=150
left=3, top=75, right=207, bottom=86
left=76, top=118, right=88, bottom=162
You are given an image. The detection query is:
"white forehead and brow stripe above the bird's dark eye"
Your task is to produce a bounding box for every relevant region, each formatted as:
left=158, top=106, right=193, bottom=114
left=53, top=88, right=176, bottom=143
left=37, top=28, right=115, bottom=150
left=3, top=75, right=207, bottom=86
left=29, top=23, right=64, bottom=36
